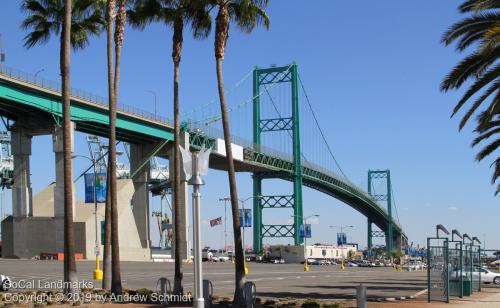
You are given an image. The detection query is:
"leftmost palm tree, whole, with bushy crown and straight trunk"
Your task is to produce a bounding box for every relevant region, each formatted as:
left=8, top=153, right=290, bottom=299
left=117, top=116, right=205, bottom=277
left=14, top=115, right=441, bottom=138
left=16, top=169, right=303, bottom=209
left=21, top=0, right=102, bottom=293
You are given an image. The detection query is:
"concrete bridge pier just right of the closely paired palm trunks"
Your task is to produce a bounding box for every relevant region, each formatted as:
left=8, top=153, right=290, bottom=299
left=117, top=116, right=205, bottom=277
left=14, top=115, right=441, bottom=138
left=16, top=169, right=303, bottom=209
left=130, top=143, right=151, bottom=248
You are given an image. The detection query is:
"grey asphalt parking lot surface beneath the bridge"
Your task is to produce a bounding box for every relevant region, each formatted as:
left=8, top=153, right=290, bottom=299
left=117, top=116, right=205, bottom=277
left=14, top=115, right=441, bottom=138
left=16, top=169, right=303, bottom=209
left=0, top=259, right=427, bottom=299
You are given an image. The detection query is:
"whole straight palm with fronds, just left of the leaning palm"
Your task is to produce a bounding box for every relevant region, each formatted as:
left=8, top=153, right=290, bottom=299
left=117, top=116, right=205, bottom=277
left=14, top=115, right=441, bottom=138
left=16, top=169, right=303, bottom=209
left=129, top=0, right=212, bottom=294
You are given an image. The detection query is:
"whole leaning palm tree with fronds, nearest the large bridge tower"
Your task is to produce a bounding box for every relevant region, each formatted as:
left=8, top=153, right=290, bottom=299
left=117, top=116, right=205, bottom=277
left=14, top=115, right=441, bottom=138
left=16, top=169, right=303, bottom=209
left=212, top=0, right=269, bottom=305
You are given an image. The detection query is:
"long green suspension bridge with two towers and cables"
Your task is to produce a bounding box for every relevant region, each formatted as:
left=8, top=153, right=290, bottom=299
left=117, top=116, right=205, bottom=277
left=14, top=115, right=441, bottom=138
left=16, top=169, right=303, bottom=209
left=0, top=64, right=407, bottom=253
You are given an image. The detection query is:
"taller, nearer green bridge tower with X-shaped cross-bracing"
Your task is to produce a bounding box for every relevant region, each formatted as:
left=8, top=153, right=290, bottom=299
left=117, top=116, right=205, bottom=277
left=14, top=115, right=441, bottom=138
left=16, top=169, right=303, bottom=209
left=253, top=64, right=303, bottom=253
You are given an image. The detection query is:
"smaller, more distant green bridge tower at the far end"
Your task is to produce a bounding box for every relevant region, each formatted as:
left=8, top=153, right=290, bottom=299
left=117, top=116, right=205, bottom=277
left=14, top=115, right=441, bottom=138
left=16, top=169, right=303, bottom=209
left=368, top=170, right=394, bottom=256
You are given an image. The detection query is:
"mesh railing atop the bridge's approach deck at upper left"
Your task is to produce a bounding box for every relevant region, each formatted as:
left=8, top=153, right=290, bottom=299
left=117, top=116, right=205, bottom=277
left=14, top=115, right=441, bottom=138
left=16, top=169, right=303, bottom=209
left=0, top=65, right=172, bottom=125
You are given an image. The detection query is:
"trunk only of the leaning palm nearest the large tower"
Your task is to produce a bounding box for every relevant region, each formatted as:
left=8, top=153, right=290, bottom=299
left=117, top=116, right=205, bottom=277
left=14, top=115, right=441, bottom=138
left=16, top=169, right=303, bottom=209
left=214, top=6, right=246, bottom=306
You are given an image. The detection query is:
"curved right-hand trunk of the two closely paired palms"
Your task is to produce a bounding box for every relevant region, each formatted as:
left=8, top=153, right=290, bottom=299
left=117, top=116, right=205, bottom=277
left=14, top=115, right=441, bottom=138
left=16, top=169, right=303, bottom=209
left=108, top=0, right=126, bottom=295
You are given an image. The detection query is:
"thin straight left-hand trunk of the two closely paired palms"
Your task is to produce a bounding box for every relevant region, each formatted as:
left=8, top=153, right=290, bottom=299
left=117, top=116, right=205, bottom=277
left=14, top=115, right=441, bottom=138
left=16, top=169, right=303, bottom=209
left=103, top=0, right=116, bottom=290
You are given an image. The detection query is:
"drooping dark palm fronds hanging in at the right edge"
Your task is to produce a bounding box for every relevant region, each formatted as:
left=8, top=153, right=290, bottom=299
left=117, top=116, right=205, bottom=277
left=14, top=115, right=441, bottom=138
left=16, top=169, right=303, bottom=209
left=441, top=0, right=500, bottom=195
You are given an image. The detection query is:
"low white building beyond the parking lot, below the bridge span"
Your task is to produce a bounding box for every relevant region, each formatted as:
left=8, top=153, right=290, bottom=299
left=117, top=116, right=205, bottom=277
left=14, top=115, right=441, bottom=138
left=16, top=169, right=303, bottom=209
left=269, top=244, right=357, bottom=263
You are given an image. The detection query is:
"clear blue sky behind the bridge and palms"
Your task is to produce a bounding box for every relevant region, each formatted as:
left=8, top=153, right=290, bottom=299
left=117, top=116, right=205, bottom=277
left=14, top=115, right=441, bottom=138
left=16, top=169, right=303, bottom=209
left=0, top=0, right=500, bottom=247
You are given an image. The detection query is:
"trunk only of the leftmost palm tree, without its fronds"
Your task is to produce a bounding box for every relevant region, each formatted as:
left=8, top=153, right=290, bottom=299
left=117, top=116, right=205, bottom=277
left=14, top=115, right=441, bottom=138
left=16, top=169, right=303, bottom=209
left=61, top=0, right=78, bottom=294
